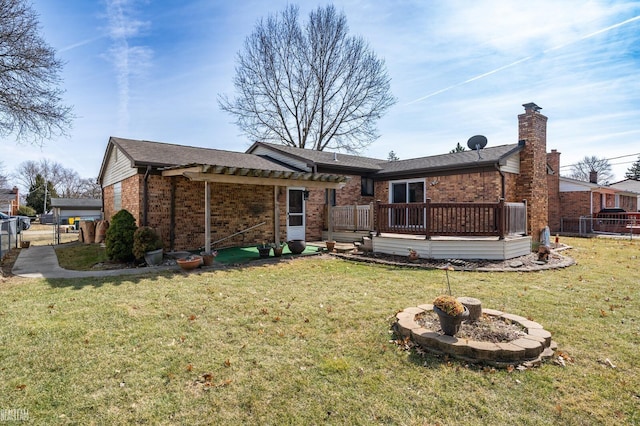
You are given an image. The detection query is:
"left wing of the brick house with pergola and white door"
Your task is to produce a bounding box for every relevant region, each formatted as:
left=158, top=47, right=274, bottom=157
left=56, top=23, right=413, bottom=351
left=98, top=137, right=347, bottom=250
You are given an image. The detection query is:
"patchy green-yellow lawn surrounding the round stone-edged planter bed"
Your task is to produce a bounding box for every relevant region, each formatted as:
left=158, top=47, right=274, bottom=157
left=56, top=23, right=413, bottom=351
left=0, top=238, right=640, bottom=425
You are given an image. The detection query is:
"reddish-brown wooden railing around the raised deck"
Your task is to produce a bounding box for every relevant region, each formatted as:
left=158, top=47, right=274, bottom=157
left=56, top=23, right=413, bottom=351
left=375, top=199, right=527, bottom=238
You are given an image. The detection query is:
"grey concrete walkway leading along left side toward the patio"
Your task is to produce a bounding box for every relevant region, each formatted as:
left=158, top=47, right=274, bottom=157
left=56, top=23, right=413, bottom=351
left=11, top=246, right=172, bottom=278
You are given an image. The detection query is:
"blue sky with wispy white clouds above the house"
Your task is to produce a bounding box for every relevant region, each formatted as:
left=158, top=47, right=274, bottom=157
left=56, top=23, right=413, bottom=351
left=0, top=0, right=640, bottom=186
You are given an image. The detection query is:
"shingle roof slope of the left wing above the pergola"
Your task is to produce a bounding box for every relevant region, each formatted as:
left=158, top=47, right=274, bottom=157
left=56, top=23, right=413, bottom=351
left=110, top=137, right=292, bottom=171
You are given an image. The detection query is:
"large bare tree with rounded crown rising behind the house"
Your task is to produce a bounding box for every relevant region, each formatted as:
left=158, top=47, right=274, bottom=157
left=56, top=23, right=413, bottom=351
left=218, top=5, right=396, bottom=153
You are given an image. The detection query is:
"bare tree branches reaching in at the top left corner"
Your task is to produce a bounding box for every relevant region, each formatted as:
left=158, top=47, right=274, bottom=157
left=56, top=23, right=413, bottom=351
left=0, top=0, right=72, bottom=145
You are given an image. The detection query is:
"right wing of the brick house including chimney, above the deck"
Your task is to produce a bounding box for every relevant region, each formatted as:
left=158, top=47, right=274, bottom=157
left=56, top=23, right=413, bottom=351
left=247, top=103, right=548, bottom=245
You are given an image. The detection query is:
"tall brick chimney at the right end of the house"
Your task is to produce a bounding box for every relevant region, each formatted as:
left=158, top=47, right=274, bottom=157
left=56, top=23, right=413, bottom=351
left=516, top=102, right=549, bottom=241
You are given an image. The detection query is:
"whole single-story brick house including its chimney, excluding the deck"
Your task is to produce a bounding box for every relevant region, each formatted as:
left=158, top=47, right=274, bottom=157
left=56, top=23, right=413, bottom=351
left=98, top=103, right=548, bottom=256
